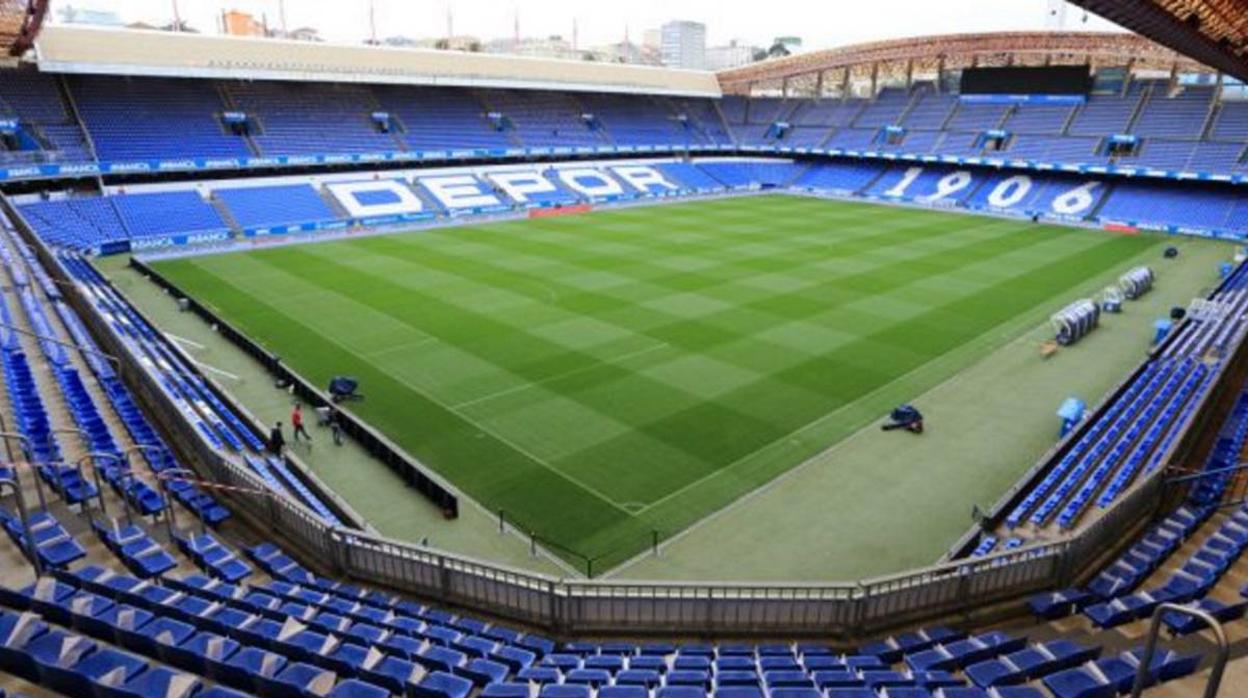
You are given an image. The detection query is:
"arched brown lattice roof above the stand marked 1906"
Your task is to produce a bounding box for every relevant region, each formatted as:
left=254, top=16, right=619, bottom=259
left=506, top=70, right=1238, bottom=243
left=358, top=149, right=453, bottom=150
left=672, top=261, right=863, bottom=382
left=719, top=31, right=1207, bottom=94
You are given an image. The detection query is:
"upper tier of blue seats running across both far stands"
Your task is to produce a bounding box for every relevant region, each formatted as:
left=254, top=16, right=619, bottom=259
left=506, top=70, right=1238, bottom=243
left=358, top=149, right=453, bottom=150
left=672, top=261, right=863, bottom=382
left=0, top=70, right=1248, bottom=183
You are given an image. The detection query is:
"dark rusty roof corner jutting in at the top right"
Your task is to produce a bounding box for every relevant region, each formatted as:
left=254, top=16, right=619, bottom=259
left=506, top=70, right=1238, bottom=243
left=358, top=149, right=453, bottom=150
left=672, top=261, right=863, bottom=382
left=1072, top=0, right=1248, bottom=81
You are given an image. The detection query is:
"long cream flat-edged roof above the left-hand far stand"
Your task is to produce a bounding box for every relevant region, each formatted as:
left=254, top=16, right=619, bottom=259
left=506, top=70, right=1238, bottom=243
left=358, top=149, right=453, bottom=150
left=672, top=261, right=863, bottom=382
left=35, top=25, right=720, bottom=96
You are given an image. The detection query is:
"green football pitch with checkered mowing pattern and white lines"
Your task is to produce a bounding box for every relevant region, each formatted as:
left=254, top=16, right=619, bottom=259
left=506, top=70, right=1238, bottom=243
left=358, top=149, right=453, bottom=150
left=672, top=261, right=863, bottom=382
left=154, top=196, right=1163, bottom=571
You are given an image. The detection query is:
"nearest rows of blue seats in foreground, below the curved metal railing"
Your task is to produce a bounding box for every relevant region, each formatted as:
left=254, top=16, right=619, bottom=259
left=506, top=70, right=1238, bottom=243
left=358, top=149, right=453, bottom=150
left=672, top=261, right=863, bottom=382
left=0, top=491, right=1199, bottom=698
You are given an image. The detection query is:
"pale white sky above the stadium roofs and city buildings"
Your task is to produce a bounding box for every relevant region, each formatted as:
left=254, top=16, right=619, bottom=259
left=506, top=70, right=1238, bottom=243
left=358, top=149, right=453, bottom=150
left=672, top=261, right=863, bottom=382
left=52, top=0, right=1114, bottom=50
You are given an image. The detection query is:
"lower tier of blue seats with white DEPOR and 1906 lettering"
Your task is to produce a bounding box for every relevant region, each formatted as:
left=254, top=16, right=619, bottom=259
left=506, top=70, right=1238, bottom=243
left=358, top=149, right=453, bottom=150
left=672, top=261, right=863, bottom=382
left=19, top=151, right=1248, bottom=252
